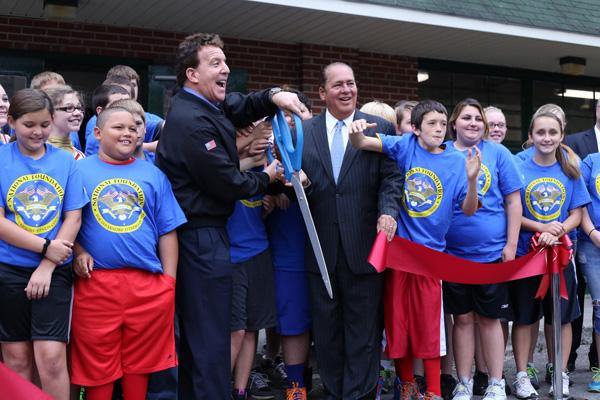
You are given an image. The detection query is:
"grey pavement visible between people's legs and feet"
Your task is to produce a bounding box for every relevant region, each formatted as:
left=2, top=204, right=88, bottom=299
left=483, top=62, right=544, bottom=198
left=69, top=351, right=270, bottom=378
left=259, top=298, right=600, bottom=400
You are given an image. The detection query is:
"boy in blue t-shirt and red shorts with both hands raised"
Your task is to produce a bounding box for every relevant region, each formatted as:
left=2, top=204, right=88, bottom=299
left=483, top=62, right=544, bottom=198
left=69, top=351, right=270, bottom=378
left=350, top=100, right=481, bottom=399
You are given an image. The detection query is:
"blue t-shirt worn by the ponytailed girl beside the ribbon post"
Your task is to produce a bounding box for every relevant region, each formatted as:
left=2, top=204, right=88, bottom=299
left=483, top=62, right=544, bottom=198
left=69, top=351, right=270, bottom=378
left=517, top=158, right=590, bottom=256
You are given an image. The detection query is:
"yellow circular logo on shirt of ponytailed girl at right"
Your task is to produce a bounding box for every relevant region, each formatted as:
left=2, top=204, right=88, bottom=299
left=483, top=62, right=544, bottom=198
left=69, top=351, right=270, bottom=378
left=525, top=178, right=567, bottom=222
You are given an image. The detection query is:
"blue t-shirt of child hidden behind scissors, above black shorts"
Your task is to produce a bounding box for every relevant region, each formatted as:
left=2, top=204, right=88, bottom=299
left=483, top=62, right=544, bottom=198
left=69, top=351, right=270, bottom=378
left=227, top=194, right=269, bottom=263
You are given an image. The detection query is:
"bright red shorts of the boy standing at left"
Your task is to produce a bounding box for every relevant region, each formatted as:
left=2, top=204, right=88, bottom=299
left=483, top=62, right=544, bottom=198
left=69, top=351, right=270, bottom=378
left=71, top=268, right=177, bottom=386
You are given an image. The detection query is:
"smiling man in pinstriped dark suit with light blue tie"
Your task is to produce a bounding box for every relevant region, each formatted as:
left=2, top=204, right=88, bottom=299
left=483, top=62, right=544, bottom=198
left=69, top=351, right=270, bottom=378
left=302, top=63, right=402, bottom=400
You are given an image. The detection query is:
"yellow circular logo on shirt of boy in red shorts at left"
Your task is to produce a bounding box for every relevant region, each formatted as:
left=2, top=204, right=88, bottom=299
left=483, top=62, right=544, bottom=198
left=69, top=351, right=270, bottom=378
left=92, top=178, right=146, bottom=233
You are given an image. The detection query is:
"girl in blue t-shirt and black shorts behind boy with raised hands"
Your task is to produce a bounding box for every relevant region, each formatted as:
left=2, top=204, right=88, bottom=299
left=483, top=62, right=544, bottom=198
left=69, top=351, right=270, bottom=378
left=443, top=99, right=523, bottom=398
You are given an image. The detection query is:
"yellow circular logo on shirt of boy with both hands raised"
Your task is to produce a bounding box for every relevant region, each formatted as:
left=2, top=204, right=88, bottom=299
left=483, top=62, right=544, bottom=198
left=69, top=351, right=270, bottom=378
left=402, top=167, right=444, bottom=218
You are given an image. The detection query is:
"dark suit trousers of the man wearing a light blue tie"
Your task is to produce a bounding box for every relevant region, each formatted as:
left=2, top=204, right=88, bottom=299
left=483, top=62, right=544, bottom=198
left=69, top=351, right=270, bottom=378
left=308, top=246, right=383, bottom=400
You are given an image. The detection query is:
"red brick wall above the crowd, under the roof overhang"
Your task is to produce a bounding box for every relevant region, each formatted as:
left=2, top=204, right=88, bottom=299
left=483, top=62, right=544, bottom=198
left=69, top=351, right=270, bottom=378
left=0, top=16, right=417, bottom=112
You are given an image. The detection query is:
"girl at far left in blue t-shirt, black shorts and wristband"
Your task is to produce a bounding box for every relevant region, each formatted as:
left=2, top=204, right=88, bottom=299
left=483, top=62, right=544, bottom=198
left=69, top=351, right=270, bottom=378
left=0, top=89, right=89, bottom=399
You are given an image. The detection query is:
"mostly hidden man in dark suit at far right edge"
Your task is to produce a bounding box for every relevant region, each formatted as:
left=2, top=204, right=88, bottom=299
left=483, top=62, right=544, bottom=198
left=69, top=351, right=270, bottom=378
left=565, top=100, right=600, bottom=371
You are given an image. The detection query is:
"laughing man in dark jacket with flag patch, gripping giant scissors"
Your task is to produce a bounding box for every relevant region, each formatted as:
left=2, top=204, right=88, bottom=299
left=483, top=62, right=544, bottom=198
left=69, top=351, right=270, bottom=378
left=156, top=33, right=308, bottom=400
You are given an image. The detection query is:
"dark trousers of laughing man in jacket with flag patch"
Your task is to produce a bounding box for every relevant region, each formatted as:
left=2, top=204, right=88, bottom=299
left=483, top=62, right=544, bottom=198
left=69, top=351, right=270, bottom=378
left=177, top=227, right=232, bottom=400
